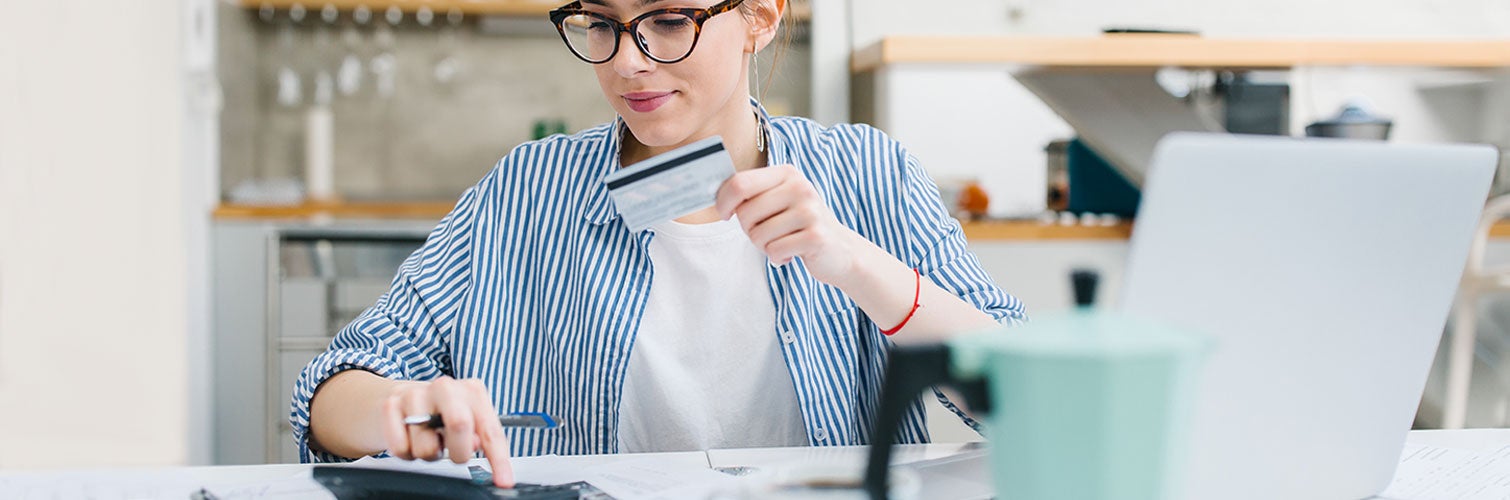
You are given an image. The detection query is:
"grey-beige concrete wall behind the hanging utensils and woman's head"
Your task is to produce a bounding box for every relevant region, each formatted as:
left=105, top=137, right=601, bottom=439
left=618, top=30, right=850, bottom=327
left=219, top=5, right=809, bottom=199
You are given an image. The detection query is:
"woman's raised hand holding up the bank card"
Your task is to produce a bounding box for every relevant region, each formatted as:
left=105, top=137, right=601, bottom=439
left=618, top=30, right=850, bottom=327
left=714, top=165, right=862, bottom=284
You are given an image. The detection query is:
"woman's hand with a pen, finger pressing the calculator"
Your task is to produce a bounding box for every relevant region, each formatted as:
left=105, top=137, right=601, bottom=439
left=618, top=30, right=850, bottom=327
left=382, top=376, right=513, bottom=488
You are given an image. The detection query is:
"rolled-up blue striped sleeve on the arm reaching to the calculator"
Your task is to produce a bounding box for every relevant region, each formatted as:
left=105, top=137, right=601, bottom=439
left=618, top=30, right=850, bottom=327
left=288, top=174, right=492, bottom=462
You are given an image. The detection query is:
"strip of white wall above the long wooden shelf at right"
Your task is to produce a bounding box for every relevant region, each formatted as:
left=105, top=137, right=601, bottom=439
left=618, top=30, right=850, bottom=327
left=851, top=0, right=1510, bottom=47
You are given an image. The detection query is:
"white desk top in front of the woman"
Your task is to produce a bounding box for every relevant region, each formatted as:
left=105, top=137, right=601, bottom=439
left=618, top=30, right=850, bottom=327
left=0, top=429, right=1510, bottom=500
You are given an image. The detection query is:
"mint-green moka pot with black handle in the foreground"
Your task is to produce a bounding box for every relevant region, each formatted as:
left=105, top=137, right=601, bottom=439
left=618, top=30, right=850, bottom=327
left=865, top=276, right=1210, bottom=500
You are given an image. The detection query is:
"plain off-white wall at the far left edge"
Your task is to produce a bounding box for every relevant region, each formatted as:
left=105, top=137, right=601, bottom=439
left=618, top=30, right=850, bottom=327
left=0, top=0, right=190, bottom=468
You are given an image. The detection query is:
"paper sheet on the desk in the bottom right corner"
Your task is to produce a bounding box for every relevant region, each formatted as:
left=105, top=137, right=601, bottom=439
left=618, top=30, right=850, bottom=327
left=1379, top=443, right=1510, bottom=500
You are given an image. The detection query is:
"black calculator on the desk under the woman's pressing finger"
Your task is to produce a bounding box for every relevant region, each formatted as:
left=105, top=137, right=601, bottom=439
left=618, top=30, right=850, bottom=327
left=314, top=465, right=612, bottom=500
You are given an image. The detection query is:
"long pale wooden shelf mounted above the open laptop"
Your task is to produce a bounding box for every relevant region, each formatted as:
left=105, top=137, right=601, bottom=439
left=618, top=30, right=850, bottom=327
left=850, top=35, right=1510, bottom=73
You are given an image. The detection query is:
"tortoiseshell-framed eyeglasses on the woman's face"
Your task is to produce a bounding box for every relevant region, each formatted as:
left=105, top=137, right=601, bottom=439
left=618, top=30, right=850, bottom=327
left=551, top=0, right=744, bottom=65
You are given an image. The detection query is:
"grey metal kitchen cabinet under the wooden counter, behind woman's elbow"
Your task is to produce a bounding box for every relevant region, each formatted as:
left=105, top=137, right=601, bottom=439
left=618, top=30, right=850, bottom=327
left=213, top=221, right=433, bottom=464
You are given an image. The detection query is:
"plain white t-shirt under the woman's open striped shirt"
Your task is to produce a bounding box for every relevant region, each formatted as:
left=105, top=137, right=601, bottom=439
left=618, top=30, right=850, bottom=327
left=619, top=219, right=808, bottom=453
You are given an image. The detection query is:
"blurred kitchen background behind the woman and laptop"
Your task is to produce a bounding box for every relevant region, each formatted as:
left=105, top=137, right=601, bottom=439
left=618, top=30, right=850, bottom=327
left=0, top=0, right=1510, bottom=468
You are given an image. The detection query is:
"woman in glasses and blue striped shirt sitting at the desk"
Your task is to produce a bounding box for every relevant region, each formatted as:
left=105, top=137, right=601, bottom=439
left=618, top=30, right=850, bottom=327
left=290, top=0, right=1024, bottom=486
